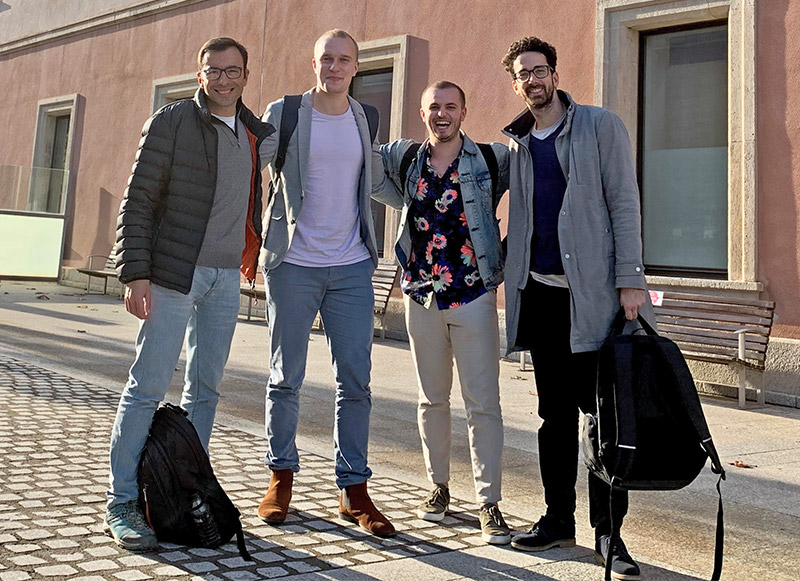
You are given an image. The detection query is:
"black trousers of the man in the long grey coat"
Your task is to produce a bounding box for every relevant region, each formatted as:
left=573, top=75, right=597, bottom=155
left=518, top=280, right=628, bottom=538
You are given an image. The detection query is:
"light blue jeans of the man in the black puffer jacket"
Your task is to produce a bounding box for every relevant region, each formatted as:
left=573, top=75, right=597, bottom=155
left=106, top=266, right=239, bottom=506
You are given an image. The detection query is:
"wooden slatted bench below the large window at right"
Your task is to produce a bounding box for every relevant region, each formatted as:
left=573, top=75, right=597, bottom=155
left=650, top=289, right=775, bottom=408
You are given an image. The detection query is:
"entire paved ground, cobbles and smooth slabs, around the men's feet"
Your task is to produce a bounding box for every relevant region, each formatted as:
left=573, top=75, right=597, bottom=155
left=0, top=281, right=800, bottom=581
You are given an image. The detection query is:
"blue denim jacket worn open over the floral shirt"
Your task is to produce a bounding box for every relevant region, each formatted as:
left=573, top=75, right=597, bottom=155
left=372, top=133, right=508, bottom=290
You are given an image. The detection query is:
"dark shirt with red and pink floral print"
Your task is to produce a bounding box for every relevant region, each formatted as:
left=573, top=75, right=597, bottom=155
left=401, top=146, right=486, bottom=310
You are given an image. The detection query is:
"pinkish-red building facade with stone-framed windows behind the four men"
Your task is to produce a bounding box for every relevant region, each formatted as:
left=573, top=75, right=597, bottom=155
left=0, top=0, right=800, bottom=406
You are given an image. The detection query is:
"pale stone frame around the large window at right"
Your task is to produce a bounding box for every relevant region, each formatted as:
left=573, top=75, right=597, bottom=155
left=594, top=0, right=763, bottom=292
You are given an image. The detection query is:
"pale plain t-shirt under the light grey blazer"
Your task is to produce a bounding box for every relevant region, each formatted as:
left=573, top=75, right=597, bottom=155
left=284, top=109, right=370, bottom=267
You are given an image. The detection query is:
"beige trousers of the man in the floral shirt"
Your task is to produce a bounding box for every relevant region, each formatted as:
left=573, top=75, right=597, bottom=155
left=404, top=291, right=503, bottom=505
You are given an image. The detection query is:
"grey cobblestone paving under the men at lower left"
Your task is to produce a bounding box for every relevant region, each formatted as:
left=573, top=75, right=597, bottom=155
left=0, top=356, right=536, bottom=581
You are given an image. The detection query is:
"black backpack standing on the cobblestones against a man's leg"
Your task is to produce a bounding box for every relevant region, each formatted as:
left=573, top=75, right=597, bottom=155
left=139, top=403, right=252, bottom=561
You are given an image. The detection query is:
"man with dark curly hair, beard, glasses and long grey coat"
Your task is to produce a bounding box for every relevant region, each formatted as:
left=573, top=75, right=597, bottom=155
left=502, top=37, right=653, bottom=579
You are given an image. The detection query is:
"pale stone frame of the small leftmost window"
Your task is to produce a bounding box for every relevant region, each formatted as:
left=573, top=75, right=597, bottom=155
left=28, top=93, right=80, bottom=216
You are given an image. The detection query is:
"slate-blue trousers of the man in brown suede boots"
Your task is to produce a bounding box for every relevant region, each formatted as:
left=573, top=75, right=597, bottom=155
left=264, top=260, right=375, bottom=488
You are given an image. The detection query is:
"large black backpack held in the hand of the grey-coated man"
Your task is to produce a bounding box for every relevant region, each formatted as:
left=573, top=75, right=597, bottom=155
left=581, top=309, right=725, bottom=581
